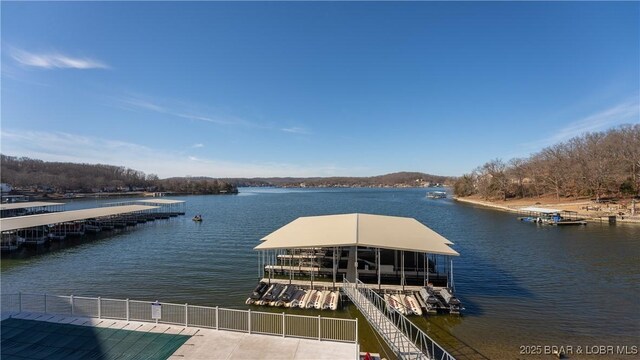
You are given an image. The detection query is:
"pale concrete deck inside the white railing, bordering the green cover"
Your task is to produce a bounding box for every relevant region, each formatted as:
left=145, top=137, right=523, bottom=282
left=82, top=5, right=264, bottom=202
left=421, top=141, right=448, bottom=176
left=2, top=313, right=358, bottom=360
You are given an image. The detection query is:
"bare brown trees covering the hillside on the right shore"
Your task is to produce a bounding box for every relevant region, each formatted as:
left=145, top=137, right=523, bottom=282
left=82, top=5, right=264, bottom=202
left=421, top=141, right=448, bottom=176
left=454, top=124, right=640, bottom=200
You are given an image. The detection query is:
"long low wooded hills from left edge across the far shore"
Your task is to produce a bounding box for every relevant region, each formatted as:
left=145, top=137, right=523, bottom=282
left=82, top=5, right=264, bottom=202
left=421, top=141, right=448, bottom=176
left=0, top=155, right=455, bottom=194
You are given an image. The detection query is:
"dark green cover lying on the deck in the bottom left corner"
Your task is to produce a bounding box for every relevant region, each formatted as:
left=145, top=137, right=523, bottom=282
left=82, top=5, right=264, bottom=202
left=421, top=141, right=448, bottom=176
left=0, top=319, right=190, bottom=360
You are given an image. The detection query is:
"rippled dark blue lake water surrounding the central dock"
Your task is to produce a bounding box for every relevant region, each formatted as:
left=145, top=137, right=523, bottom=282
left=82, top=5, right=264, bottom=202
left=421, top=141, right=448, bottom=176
left=1, top=189, right=640, bottom=359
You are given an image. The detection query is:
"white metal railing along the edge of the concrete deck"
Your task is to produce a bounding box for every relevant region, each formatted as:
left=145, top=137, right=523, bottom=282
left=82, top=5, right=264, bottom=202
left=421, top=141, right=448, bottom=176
left=0, top=293, right=358, bottom=344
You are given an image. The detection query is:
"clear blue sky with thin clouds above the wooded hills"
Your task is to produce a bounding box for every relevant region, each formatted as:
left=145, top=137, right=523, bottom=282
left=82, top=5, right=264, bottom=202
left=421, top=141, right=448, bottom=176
left=0, top=2, right=640, bottom=177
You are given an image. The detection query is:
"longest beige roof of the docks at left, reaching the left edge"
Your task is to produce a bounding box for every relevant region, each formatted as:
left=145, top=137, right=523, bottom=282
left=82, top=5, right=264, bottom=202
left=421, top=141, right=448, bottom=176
left=0, top=205, right=157, bottom=231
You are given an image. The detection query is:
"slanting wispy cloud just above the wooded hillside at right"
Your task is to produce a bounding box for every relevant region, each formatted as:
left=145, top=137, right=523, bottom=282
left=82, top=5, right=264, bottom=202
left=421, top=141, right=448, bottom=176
left=522, top=96, right=640, bottom=149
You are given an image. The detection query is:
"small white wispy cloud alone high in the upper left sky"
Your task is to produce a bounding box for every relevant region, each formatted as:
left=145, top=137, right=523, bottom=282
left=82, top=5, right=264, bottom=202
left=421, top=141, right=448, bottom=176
left=10, top=49, right=109, bottom=69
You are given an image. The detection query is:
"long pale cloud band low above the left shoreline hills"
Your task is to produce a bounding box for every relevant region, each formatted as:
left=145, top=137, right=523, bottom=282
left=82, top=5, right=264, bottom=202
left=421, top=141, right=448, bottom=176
left=0, top=129, right=351, bottom=178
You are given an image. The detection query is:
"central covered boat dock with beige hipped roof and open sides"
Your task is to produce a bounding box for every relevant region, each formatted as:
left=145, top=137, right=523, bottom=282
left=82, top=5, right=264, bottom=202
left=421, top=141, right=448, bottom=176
left=255, top=214, right=459, bottom=290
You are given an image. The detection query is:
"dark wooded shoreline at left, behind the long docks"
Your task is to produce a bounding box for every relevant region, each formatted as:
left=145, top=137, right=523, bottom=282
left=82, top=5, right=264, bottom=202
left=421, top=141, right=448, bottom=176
left=0, top=155, right=237, bottom=194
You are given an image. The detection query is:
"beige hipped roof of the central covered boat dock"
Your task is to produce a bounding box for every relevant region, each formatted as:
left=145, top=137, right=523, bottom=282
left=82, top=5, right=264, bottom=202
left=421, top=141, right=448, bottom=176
left=255, top=214, right=460, bottom=256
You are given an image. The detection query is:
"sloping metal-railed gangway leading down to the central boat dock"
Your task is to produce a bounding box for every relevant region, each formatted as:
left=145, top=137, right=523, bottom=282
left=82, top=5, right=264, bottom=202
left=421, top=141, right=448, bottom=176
left=342, top=278, right=455, bottom=360
